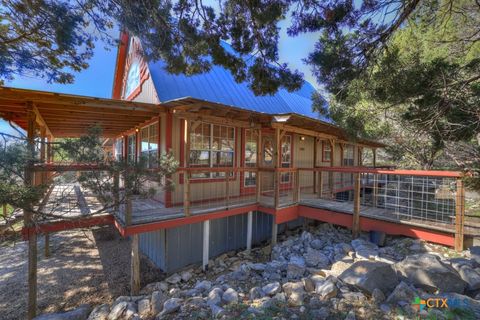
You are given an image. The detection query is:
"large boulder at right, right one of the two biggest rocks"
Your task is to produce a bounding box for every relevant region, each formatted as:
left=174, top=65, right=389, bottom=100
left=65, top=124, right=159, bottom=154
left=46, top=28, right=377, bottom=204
left=395, top=254, right=466, bottom=293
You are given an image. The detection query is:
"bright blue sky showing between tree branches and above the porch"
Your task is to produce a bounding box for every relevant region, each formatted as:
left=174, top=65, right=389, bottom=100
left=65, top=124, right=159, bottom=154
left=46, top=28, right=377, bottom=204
left=0, top=16, right=319, bottom=133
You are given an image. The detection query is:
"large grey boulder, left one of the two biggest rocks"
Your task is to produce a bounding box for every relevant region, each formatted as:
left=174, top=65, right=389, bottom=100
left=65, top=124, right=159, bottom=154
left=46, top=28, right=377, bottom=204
left=339, top=261, right=398, bottom=295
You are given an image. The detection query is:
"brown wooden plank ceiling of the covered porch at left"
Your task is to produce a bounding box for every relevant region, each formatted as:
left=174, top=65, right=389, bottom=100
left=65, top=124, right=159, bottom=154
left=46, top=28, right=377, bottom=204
left=0, top=87, right=165, bottom=137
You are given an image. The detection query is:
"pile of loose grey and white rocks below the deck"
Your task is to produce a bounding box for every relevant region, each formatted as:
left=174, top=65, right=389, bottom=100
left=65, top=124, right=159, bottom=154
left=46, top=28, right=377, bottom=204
left=35, top=224, right=480, bottom=320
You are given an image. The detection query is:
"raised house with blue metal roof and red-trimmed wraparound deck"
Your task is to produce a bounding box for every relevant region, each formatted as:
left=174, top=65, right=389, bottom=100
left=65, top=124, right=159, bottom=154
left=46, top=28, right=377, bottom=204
left=0, top=33, right=464, bottom=288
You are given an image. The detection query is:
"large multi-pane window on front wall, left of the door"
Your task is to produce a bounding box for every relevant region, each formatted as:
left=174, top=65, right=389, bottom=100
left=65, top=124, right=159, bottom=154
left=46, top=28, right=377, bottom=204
left=190, top=123, right=235, bottom=178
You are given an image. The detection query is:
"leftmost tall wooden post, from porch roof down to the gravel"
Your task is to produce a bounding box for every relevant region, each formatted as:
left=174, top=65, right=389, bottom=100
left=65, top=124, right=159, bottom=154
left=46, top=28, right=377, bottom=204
left=23, top=104, right=37, bottom=319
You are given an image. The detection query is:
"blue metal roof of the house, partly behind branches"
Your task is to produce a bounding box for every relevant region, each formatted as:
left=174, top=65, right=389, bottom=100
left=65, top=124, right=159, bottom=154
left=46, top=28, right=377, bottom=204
left=149, top=45, right=331, bottom=122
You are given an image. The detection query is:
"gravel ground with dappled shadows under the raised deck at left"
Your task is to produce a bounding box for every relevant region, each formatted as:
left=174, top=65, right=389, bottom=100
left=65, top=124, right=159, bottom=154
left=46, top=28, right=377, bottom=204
left=0, top=226, right=164, bottom=320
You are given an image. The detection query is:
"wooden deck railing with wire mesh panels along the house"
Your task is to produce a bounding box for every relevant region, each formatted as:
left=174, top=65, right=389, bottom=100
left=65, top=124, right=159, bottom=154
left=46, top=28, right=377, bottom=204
left=31, top=165, right=464, bottom=250
